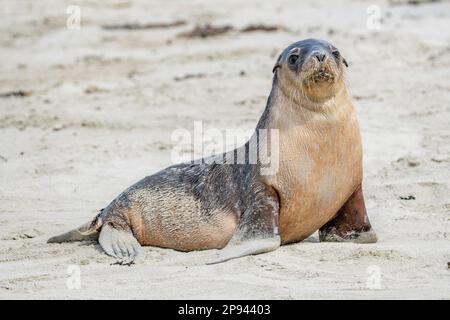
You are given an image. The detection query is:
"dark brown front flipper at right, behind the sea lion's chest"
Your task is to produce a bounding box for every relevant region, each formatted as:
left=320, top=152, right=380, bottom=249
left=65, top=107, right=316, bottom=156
left=319, top=185, right=377, bottom=243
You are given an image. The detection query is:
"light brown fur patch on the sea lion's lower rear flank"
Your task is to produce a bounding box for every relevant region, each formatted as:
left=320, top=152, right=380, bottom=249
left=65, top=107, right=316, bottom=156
left=124, top=190, right=237, bottom=251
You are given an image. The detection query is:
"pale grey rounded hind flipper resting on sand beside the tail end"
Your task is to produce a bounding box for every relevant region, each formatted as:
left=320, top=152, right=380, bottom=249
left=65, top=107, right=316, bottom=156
left=98, top=223, right=142, bottom=264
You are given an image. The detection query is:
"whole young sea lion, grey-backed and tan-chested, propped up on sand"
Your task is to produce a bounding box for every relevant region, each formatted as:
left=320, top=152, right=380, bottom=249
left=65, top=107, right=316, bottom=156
left=48, top=39, right=377, bottom=263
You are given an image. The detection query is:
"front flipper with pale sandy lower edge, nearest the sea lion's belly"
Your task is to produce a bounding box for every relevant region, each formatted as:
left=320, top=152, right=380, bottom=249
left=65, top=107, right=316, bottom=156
left=207, top=187, right=281, bottom=264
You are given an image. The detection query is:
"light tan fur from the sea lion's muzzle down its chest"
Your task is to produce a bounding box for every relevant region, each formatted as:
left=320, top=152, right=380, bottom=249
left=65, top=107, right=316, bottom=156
left=266, top=46, right=362, bottom=243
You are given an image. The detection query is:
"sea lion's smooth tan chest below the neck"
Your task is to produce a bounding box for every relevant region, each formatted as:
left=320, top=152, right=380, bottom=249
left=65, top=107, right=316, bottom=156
left=272, top=106, right=362, bottom=243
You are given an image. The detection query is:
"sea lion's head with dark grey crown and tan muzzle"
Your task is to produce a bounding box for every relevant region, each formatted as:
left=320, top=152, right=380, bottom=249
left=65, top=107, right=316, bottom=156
left=274, top=39, right=347, bottom=102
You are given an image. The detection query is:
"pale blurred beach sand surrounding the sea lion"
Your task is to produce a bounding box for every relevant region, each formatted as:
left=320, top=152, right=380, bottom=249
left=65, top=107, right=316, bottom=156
left=0, top=0, right=450, bottom=299
